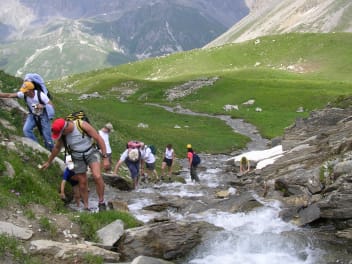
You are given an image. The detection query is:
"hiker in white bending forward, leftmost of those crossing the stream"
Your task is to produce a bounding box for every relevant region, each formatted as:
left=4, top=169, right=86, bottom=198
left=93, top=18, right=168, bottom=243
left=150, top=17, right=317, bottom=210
left=114, top=141, right=141, bottom=189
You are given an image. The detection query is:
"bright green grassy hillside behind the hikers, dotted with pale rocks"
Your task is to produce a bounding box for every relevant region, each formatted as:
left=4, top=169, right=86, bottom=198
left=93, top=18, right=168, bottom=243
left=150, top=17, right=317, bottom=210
left=46, top=33, right=352, bottom=152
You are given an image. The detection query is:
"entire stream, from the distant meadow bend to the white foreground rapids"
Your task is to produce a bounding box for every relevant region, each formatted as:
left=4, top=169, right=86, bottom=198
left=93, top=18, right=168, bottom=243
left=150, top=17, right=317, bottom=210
left=84, top=104, right=346, bottom=264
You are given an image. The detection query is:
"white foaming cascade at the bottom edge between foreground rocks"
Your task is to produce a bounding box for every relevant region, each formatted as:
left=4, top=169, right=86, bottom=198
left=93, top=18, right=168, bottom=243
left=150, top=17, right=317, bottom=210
left=185, top=206, right=322, bottom=264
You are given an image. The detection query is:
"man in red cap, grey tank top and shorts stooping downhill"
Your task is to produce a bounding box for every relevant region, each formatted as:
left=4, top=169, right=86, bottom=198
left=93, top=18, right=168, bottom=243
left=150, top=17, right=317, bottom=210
left=42, top=118, right=110, bottom=211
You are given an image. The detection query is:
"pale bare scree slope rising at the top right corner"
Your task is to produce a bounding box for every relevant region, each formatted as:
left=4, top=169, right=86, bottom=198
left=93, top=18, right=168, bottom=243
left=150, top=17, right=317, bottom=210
left=205, top=0, right=352, bottom=48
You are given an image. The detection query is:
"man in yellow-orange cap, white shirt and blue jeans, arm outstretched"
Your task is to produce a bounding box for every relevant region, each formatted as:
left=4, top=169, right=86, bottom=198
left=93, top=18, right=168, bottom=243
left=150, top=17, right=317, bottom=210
left=0, top=81, right=54, bottom=151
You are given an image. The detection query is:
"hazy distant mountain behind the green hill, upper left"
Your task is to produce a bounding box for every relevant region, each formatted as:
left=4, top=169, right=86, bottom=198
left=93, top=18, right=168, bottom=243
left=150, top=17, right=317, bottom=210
left=0, top=0, right=248, bottom=79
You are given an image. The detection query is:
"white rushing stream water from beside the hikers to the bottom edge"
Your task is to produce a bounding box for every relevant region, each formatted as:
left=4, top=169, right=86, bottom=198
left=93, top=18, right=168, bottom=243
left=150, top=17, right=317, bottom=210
left=121, top=157, right=324, bottom=264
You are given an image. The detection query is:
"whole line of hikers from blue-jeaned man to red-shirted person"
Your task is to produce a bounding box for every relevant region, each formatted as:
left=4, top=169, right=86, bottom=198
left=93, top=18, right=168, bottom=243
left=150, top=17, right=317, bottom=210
left=0, top=73, right=200, bottom=211
